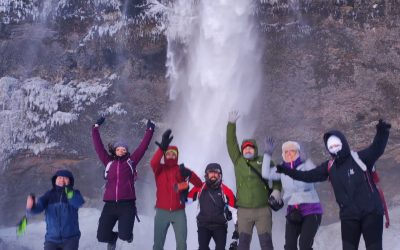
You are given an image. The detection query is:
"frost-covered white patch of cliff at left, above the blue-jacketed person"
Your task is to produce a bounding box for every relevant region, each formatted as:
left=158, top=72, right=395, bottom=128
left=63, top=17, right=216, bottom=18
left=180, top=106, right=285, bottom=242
left=0, top=74, right=124, bottom=164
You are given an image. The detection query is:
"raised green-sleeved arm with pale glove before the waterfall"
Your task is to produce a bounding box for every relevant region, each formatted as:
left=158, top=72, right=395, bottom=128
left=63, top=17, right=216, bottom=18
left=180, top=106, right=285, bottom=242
left=226, top=111, right=241, bottom=163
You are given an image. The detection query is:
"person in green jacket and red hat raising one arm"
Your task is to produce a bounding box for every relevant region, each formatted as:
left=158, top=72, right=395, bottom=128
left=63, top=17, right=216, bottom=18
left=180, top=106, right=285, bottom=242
left=226, top=111, right=282, bottom=250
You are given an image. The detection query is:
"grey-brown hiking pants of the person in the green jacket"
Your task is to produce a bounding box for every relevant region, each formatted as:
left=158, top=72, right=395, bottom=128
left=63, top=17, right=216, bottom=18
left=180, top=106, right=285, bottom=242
left=237, top=206, right=274, bottom=250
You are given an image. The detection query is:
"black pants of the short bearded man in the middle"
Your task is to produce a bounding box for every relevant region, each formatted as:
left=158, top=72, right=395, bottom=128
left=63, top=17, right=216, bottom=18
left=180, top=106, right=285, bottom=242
left=197, top=226, right=228, bottom=250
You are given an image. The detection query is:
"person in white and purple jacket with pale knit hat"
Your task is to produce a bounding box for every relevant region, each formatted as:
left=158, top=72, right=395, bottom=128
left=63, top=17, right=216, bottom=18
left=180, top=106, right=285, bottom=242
left=262, top=137, right=322, bottom=250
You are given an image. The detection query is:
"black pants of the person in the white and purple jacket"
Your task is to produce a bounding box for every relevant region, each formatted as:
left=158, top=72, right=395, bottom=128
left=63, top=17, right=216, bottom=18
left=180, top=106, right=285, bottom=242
left=285, top=214, right=321, bottom=250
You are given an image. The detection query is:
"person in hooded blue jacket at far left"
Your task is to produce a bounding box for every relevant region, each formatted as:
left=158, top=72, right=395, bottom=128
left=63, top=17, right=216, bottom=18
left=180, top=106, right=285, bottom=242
left=26, top=170, right=85, bottom=250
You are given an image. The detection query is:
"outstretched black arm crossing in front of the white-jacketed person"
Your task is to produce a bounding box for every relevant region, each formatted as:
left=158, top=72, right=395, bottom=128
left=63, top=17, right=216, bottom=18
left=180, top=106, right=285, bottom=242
left=276, top=161, right=329, bottom=182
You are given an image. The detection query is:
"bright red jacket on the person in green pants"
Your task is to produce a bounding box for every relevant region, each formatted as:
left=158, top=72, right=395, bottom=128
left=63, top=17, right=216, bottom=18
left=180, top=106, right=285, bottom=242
left=150, top=146, right=202, bottom=211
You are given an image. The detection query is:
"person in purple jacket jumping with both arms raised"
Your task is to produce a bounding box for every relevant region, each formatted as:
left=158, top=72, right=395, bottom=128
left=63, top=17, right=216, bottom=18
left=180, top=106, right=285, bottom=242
left=92, top=117, right=155, bottom=250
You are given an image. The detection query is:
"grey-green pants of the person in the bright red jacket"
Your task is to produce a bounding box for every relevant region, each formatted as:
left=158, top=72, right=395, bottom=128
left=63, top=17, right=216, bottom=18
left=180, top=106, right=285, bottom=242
left=153, top=208, right=187, bottom=250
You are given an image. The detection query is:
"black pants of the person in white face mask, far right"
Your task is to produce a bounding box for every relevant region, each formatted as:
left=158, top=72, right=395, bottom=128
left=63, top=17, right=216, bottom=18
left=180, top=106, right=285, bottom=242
left=341, top=213, right=383, bottom=250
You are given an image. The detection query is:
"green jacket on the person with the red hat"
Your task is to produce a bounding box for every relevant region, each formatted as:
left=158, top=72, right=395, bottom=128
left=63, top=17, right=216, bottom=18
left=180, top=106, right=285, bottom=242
left=226, top=123, right=282, bottom=208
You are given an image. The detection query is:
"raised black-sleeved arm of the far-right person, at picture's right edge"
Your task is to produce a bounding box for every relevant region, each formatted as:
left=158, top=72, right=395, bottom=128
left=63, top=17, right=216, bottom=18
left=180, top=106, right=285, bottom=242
left=358, top=120, right=391, bottom=170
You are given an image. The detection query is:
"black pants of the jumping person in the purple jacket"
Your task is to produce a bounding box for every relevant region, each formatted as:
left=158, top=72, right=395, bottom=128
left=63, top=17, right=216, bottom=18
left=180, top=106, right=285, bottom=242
left=97, top=201, right=136, bottom=243
